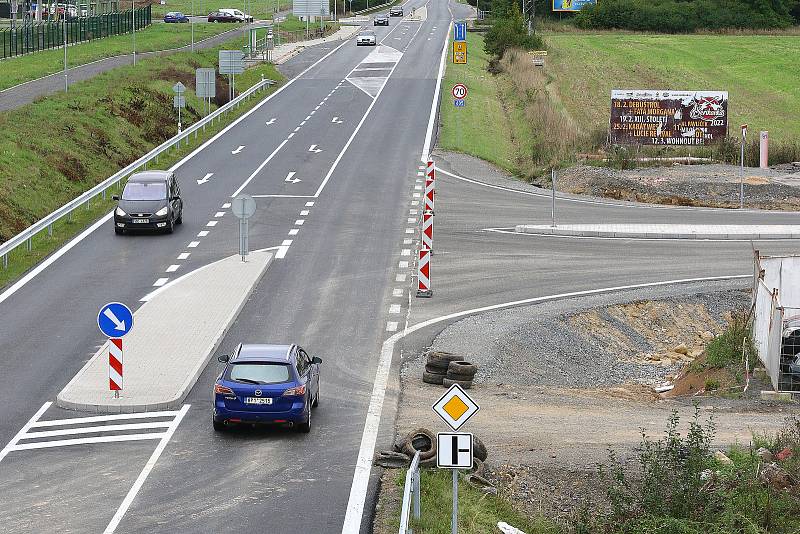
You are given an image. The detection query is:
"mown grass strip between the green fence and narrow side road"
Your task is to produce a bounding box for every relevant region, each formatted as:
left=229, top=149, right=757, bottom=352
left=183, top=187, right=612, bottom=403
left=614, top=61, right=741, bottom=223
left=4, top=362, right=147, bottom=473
left=0, top=23, right=236, bottom=90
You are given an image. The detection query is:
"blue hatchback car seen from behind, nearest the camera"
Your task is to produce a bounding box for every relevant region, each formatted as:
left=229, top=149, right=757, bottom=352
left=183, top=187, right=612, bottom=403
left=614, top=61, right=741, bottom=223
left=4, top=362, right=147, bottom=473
left=214, top=344, right=322, bottom=432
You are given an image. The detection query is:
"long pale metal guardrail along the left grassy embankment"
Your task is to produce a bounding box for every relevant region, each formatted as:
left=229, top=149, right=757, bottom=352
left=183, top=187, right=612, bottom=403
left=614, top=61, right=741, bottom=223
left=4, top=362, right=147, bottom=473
left=0, top=76, right=276, bottom=269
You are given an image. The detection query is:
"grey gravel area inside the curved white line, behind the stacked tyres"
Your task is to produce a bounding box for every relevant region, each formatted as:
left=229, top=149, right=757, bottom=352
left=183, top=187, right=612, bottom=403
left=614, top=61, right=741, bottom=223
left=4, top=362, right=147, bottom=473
left=401, top=280, right=749, bottom=388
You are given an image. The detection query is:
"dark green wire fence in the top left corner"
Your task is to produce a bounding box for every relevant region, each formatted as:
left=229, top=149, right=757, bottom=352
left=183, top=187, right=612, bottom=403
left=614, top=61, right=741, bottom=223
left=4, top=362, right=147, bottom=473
left=0, top=5, right=153, bottom=59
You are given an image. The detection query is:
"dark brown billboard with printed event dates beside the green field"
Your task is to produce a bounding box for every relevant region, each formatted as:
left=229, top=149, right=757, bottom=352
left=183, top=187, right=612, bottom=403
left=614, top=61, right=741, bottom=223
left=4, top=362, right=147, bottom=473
left=610, top=89, right=728, bottom=146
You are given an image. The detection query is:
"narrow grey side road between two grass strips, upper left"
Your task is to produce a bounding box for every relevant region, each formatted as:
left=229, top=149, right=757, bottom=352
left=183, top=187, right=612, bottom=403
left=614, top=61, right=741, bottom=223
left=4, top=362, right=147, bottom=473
left=0, top=26, right=249, bottom=111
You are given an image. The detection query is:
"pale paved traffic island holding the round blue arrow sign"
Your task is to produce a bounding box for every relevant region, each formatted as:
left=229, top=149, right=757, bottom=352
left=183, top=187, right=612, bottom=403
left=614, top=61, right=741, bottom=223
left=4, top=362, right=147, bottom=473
left=56, top=251, right=273, bottom=413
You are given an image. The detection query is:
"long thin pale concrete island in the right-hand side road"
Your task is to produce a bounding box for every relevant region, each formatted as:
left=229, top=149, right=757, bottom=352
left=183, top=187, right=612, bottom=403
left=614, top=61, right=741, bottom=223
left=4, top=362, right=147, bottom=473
left=514, top=224, right=800, bottom=240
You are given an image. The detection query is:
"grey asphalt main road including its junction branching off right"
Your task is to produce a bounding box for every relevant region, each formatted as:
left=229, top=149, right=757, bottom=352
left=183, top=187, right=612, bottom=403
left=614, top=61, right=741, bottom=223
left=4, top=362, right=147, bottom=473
left=0, top=0, right=795, bottom=533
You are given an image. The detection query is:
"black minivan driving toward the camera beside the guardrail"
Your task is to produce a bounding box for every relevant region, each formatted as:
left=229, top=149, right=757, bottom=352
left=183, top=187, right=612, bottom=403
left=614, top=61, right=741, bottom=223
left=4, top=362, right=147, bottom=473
left=113, top=171, right=183, bottom=234
